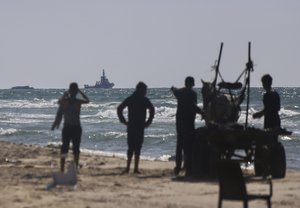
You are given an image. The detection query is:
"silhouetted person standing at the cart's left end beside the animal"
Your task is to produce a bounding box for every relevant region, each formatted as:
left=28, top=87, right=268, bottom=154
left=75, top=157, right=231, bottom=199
left=171, top=77, right=203, bottom=175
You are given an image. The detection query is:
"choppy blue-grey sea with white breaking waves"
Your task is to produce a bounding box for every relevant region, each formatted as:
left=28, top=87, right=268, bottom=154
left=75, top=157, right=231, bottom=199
left=0, top=87, right=300, bottom=170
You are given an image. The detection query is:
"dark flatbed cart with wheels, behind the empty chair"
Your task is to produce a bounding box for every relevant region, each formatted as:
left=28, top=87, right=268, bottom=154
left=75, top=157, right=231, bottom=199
left=193, top=126, right=291, bottom=178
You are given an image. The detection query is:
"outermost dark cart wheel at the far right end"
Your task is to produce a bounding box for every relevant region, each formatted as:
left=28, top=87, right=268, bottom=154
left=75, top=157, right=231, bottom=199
left=271, top=142, right=286, bottom=178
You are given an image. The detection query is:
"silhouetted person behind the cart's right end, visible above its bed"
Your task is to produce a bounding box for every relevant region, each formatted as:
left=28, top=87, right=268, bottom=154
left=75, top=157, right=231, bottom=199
left=253, top=74, right=281, bottom=129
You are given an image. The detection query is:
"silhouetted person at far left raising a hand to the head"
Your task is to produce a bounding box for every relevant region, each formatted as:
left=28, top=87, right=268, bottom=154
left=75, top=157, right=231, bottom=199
left=51, top=82, right=90, bottom=172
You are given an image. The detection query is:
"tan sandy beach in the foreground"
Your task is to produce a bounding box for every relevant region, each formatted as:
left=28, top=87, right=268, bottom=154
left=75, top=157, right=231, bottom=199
left=0, top=142, right=300, bottom=208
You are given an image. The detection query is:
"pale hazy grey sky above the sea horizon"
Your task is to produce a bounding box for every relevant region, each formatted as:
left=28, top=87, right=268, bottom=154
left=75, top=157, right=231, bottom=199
left=0, top=0, right=300, bottom=89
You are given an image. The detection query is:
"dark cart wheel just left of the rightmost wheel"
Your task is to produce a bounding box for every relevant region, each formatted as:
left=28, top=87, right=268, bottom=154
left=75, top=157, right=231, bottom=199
left=254, top=146, right=270, bottom=176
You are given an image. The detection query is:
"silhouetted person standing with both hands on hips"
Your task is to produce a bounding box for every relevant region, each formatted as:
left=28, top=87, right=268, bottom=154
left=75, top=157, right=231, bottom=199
left=117, top=82, right=154, bottom=173
